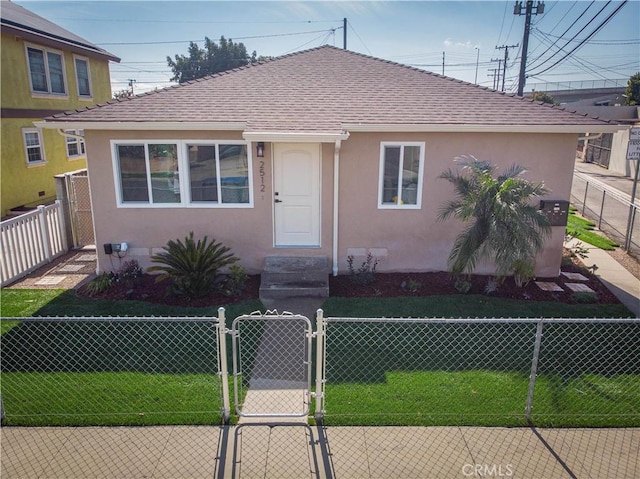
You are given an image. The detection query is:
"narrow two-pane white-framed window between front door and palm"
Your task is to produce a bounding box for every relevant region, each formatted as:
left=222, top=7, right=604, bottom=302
left=378, top=142, right=424, bottom=209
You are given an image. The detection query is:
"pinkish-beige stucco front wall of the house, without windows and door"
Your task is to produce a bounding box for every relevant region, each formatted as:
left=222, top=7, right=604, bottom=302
left=85, top=130, right=578, bottom=276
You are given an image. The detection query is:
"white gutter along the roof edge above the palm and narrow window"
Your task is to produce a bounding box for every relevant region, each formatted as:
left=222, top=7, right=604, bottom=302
left=341, top=123, right=630, bottom=133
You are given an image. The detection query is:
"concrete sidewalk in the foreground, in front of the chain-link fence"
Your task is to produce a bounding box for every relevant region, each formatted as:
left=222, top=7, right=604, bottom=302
left=1, top=424, right=640, bottom=479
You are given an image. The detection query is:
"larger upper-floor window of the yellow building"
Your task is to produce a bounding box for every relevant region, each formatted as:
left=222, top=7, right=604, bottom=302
left=27, top=47, right=67, bottom=95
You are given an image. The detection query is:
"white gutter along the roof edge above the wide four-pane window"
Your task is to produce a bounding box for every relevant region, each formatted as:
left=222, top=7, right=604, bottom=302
left=33, top=120, right=246, bottom=131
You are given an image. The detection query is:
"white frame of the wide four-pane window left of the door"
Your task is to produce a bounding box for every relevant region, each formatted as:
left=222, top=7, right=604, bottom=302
left=111, top=139, right=254, bottom=209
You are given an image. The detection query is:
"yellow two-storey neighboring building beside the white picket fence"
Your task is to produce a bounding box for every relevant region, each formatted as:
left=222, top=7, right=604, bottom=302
left=0, top=0, right=120, bottom=217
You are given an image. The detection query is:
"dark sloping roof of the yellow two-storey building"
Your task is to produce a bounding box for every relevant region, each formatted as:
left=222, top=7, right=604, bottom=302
left=0, top=0, right=120, bottom=62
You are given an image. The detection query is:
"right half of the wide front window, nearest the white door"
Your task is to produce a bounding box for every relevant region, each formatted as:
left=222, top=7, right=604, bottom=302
left=187, top=143, right=249, bottom=204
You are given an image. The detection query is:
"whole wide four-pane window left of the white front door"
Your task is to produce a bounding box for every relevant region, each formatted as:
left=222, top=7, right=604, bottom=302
left=112, top=140, right=252, bottom=207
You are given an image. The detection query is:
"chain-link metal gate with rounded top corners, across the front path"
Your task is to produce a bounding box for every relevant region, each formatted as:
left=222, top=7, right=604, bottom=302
left=229, top=313, right=315, bottom=417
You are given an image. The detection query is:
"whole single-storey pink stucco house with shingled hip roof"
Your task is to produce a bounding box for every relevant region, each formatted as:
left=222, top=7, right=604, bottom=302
left=37, top=46, right=620, bottom=276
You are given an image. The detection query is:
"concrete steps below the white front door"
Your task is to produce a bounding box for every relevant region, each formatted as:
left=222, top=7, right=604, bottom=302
left=260, top=256, right=329, bottom=299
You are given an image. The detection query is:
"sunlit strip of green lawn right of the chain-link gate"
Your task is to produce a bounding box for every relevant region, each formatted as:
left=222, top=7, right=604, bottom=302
left=325, top=370, right=640, bottom=427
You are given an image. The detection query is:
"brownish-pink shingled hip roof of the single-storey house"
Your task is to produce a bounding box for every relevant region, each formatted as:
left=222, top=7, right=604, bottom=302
left=40, top=46, right=620, bottom=136
